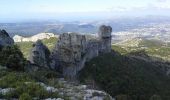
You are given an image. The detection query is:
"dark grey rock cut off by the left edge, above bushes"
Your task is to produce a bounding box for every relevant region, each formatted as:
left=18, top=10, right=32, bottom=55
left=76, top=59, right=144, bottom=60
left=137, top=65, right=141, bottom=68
left=0, top=30, right=14, bottom=47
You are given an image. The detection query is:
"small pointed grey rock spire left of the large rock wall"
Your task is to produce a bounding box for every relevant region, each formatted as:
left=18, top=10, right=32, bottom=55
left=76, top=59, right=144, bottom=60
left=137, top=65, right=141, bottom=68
left=30, top=40, right=50, bottom=68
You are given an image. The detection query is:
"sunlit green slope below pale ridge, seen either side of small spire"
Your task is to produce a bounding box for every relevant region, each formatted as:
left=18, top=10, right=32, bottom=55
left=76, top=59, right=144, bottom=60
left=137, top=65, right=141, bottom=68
left=16, top=37, right=57, bottom=59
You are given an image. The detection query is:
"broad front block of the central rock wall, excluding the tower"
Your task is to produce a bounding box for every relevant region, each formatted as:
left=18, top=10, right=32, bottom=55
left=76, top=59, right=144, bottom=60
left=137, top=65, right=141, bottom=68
left=55, top=33, right=86, bottom=77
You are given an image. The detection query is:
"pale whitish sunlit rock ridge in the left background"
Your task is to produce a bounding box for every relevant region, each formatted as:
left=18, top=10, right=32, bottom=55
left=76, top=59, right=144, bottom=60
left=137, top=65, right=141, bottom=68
left=13, top=33, right=58, bottom=42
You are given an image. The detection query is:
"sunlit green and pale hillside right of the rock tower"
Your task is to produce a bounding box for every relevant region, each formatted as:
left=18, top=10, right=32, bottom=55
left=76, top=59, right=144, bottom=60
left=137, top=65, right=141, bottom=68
left=112, top=38, right=170, bottom=61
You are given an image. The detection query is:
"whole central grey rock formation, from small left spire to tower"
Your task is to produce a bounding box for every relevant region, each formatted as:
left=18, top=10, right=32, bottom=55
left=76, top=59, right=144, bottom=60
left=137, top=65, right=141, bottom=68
left=30, top=25, right=112, bottom=79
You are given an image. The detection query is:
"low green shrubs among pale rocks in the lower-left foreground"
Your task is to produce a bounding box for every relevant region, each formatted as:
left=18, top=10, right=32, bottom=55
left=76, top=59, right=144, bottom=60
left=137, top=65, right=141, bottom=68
left=0, top=70, right=61, bottom=100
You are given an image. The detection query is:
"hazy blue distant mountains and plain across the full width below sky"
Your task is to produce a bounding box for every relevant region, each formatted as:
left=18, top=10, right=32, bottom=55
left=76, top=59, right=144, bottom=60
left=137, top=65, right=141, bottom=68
left=0, top=16, right=170, bottom=41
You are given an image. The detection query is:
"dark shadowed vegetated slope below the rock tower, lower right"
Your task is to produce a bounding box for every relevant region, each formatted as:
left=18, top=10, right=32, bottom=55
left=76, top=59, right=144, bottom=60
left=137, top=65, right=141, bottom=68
left=79, top=52, right=170, bottom=100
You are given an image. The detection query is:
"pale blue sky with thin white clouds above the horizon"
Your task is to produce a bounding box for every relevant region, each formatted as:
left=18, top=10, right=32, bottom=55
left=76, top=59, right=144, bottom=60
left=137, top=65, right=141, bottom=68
left=0, top=0, right=170, bottom=21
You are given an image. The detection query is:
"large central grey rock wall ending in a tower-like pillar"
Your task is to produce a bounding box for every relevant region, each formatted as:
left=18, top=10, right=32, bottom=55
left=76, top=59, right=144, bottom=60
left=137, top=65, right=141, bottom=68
left=52, top=25, right=112, bottom=78
